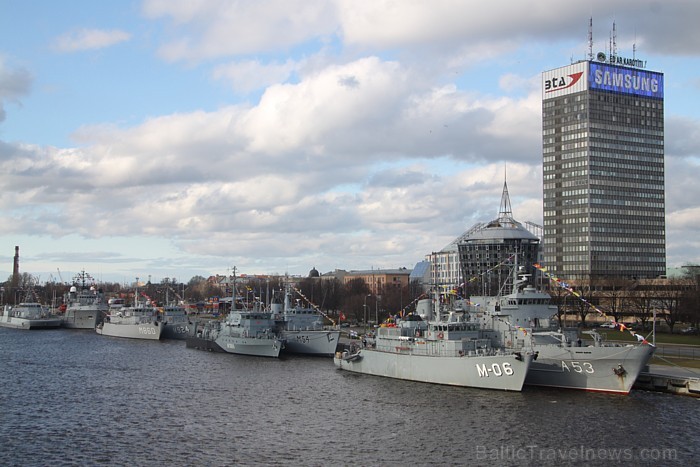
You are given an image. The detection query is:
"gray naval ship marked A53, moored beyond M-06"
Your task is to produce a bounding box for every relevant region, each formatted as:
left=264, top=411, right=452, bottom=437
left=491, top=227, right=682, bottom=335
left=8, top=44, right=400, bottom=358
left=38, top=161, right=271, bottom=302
left=469, top=261, right=655, bottom=394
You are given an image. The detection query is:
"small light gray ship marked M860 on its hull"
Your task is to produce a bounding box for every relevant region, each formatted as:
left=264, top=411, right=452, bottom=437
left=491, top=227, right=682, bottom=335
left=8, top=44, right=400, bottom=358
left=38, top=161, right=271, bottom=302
left=95, top=303, right=163, bottom=340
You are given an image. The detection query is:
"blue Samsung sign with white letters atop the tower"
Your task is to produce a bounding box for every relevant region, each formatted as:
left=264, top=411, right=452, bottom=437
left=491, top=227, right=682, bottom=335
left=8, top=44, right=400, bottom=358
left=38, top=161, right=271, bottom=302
left=588, top=62, right=664, bottom=99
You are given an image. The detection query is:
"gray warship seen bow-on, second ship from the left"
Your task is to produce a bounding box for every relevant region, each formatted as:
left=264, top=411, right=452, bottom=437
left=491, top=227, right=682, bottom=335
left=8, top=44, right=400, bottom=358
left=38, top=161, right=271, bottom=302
left=62, top=271, right=109, bottom=329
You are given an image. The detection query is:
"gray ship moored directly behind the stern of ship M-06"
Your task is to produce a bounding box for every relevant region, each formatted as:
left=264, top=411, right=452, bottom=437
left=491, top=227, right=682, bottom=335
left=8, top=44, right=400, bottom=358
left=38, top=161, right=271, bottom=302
left=270, top=288, right=340, bottom=357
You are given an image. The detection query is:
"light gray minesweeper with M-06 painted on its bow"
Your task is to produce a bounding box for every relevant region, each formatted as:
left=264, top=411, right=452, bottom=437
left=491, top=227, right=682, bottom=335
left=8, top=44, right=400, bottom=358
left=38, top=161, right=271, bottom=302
left=333, top=299, right=533, bottom=391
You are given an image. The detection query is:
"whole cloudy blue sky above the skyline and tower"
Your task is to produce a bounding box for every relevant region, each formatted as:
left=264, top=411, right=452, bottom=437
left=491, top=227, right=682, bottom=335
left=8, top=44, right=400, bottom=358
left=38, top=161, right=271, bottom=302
left=0, top=0, right=700, bottom=282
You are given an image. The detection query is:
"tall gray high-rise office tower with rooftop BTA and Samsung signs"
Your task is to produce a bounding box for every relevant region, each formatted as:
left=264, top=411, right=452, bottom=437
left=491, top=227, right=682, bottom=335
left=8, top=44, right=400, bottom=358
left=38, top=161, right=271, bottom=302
left=542, top=53, right=666, bottom=280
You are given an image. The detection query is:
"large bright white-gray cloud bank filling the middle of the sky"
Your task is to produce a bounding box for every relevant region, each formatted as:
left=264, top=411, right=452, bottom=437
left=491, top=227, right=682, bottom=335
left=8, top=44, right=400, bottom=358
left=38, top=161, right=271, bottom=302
left=0, top=48, right=548, bottom=267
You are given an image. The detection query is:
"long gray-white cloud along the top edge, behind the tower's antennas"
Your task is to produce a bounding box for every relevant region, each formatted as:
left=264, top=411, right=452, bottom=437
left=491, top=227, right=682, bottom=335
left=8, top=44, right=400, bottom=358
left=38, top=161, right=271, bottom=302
left=138, top=0, right=700, bottom=63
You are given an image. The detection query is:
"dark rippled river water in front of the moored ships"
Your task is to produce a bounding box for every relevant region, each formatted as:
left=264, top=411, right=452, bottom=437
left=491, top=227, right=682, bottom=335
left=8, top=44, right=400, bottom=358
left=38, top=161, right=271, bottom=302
left=0, top=328, right=700, bottom=466
